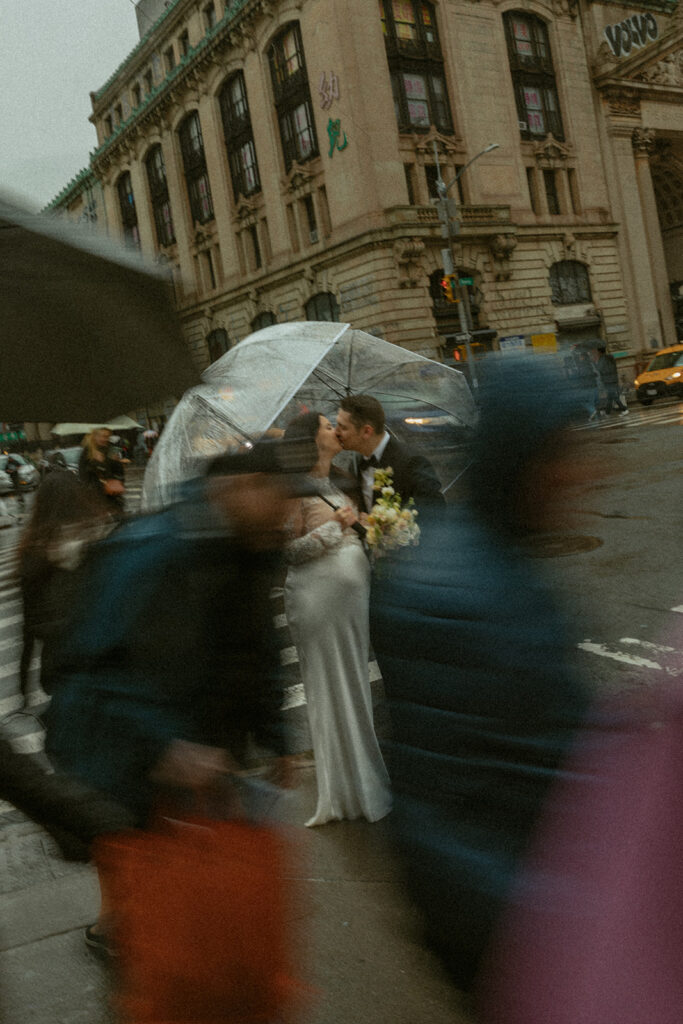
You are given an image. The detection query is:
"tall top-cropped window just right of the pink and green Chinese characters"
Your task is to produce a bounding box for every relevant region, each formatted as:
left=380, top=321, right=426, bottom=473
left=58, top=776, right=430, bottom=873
left=380, top=0, right=453, bottom=133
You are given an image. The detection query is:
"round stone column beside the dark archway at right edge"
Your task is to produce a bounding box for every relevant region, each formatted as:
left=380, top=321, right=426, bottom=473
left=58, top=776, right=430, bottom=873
left=633, top=128, right=676, bottom=345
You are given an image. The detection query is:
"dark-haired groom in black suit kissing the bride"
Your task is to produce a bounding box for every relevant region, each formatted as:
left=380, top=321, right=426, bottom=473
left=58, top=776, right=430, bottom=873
left=336, top=394, right=444, bottom=512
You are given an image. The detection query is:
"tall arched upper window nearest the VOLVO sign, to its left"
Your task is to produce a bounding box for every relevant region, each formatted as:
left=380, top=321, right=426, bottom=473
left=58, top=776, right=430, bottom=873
left=503, top=10, right=564, bottom=139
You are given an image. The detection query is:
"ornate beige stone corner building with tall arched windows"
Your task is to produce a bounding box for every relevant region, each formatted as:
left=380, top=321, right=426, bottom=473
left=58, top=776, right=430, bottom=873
left=51, top=0, right=683, bottom=373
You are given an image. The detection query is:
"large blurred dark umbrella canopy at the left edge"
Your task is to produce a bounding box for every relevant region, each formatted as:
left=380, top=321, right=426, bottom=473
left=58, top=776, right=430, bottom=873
left=0, top=198, right=199, bottom=422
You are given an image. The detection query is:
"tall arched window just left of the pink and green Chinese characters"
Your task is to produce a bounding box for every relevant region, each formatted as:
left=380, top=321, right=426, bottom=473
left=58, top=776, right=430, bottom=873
left=268, top=22, right=317, bottom=171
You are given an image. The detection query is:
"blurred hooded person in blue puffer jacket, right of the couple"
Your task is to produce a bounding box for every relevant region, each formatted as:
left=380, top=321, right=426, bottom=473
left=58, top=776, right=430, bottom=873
left=371, top=355, right=587, bottom=990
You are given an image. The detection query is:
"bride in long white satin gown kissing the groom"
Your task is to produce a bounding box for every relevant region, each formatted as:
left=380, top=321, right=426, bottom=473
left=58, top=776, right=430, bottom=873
left=285, top=413, right=391, bottom=826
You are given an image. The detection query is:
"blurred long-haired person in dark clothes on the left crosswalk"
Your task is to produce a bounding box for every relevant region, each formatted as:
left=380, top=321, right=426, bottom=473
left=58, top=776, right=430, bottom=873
left=18, top=473, right=113, bottom=707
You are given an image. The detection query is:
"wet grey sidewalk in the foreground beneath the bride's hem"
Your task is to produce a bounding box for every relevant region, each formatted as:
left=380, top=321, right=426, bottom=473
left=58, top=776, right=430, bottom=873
left=0, top=768, right=468, bottom=1024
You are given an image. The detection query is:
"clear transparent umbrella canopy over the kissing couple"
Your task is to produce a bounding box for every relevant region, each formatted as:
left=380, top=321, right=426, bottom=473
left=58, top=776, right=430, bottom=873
left=143, top=321, right=476, bottom=507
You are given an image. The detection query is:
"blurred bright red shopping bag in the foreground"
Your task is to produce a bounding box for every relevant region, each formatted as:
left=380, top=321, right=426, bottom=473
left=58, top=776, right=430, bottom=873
left=95, top=819, right=298, bottom=1024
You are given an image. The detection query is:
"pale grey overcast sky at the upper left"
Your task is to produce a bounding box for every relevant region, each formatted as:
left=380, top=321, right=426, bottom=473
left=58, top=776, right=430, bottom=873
left=0, top=0, right=139, bottom=208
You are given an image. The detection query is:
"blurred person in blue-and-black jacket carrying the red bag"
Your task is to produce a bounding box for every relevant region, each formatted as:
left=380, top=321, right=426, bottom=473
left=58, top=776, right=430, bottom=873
left=47, top=444, right=305, bottom=948
